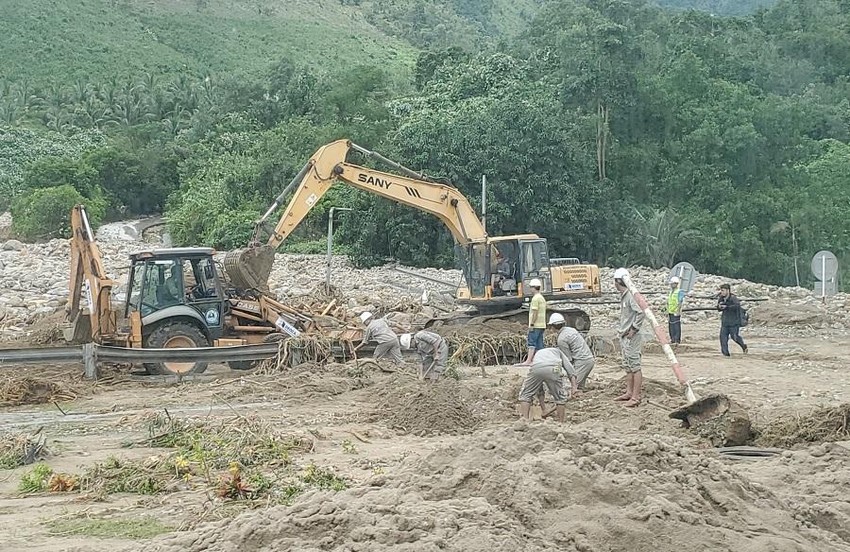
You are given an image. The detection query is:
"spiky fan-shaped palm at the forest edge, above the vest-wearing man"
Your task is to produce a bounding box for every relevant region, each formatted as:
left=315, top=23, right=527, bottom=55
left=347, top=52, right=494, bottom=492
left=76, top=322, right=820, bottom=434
left=635, top=207, right=702, bottom=268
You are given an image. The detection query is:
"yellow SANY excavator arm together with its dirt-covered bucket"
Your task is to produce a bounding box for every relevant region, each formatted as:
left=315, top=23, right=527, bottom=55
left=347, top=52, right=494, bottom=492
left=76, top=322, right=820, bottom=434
left=224, top=140, right=487, bottom=290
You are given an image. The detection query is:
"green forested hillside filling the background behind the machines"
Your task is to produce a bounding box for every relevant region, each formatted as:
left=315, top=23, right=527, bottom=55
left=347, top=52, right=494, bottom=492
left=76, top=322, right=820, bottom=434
left=0, top=0, right=850, bottom=283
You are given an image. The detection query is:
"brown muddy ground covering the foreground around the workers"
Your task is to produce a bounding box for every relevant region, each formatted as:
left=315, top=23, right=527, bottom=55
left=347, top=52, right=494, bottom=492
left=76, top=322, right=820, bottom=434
left=0, top=320, right=850, bottom=552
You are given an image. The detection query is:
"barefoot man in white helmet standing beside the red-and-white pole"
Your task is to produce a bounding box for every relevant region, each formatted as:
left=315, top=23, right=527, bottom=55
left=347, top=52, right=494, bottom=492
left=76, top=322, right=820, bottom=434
left=614, top=268, right=646, bottom=408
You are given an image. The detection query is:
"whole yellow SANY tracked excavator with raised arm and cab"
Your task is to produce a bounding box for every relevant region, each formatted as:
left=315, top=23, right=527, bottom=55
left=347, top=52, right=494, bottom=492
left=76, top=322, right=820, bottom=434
left=224, top=140, right=602, bottom=330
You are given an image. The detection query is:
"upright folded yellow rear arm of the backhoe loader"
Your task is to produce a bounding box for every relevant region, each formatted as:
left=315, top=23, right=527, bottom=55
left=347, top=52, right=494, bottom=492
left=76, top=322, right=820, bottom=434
left=65, top=205, right=117, bottom=342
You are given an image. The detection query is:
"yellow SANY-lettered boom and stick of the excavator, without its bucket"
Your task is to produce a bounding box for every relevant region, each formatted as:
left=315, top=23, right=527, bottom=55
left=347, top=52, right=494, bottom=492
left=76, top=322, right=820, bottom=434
left=259, top=140, right=487, bottom=248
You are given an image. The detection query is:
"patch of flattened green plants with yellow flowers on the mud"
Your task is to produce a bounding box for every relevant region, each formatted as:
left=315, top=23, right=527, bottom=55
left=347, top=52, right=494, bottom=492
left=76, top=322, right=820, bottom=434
left=19, top=412, right=348, bottom=505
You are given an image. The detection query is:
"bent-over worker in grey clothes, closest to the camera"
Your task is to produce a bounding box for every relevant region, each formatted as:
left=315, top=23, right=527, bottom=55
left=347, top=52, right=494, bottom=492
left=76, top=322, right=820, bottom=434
left=518, top=347, right=578, bottom=422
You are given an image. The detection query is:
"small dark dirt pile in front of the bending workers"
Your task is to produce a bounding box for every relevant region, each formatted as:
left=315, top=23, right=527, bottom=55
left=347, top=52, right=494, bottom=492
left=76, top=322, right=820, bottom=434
left=372, top=374, right=480, bottom=435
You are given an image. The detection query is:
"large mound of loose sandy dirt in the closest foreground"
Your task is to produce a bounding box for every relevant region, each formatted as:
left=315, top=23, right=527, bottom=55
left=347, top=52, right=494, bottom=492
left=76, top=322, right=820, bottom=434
left=144, top=422, right=850, bottom=552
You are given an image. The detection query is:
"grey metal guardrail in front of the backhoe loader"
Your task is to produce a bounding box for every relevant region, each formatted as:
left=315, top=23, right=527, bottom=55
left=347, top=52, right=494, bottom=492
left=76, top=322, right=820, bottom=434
left=0, top=343, right=278, bottom=379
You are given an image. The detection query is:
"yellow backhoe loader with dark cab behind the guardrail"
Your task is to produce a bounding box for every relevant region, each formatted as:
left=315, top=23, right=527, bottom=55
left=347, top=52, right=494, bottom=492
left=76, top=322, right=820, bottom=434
left=64, top=205, right=361, bottom=375
